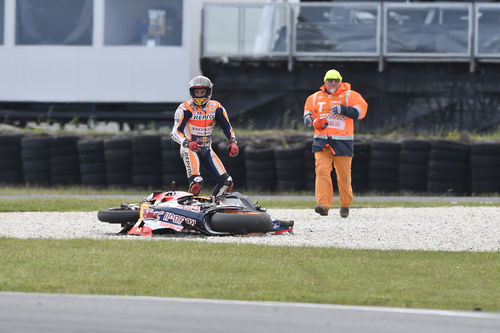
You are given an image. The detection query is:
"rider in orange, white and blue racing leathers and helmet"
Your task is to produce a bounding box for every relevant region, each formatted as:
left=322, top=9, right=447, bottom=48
left=171, top=76, right=239, bottom=201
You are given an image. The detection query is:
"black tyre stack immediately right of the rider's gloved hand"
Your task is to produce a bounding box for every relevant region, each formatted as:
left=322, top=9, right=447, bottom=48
left=245, top=142, right=276, bottom=191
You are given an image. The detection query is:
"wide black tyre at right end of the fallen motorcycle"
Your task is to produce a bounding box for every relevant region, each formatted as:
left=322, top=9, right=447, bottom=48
left=209, top=212, right=273, bottom=234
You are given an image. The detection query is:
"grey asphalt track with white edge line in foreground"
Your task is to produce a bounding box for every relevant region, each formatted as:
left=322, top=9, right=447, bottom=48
left=0, top=292, right=500, bottom=333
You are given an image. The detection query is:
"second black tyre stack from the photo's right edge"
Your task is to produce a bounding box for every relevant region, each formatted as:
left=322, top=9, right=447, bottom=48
left=427, top=140, right=469, bottom=195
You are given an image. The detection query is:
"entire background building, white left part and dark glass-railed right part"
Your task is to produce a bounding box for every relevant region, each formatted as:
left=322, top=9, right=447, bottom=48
left=0, top=0, right=500, bottom=133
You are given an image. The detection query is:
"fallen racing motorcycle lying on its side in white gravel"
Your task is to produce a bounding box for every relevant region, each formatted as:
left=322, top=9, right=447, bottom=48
left=97, top=191, right=294, bottom=236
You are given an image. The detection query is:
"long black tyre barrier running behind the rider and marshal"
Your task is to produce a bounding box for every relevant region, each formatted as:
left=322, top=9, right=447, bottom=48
left=0, top=134, right=500, bottom=195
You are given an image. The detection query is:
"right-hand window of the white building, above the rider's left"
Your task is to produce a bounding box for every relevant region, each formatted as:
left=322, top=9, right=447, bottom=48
left=104, top=0, right=182, bottom=46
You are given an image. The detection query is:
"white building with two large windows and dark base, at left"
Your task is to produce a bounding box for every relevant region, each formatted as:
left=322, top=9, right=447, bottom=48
left=0, top=0, right=260, bottom=127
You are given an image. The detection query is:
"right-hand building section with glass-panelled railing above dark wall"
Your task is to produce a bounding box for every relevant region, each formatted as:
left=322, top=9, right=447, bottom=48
left=202, top=1, right=500, bottom=134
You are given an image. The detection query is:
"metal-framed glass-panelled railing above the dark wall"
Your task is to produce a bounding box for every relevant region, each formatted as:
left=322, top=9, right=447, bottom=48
left=201, top=2, right=500, bottom=71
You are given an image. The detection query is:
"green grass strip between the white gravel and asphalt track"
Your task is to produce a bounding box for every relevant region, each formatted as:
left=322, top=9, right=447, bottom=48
left=0, top=238, right=500, bottom=311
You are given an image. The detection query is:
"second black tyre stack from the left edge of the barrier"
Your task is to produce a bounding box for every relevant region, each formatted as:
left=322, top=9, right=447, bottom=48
left=21, top=136, right=52, bottom=185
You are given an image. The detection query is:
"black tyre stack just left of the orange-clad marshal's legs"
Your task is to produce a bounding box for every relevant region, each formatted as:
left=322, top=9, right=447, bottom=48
left=274, top=143, right=305, bottom=192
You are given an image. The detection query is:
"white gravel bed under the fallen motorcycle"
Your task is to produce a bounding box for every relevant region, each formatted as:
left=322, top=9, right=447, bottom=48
left=0, top=207, right=500, bottom=251
